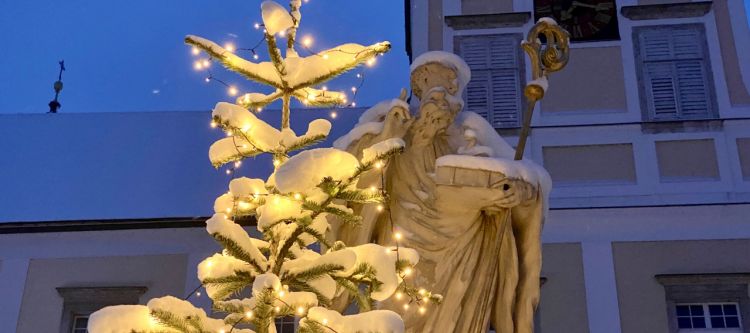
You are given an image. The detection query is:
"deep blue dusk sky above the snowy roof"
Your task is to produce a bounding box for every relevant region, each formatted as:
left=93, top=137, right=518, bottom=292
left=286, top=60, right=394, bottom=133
left=0, top=0, right=408, bottom=113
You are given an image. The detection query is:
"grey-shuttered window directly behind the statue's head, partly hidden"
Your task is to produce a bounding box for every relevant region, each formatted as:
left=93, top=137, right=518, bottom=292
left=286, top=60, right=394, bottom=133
left=455, top=34, right=524, bottom=128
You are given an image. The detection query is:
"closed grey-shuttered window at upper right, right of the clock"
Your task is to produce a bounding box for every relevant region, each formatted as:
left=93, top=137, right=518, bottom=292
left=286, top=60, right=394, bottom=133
left=633, top=24, right=716, bottom=121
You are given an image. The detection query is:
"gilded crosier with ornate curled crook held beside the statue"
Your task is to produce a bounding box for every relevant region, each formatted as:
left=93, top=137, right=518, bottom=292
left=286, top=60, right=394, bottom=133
left=515, top=17, right=570, bottom=160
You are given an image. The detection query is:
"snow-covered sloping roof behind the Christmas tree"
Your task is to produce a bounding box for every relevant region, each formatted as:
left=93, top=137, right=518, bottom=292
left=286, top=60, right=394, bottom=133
left=0, top=108, right=364, bottom=222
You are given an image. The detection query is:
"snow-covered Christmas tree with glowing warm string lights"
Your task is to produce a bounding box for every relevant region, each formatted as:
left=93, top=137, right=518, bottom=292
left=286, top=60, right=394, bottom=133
left=88, top=0, right=441, bottom=333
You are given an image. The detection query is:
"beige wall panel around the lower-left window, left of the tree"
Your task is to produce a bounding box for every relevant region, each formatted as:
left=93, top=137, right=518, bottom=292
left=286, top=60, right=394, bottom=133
left=17, top=254, right=187, bottom=333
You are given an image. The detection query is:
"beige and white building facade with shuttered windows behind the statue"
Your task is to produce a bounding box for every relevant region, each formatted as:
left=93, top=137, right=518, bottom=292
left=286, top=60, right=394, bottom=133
left=406, top=0, right=750, bottom=333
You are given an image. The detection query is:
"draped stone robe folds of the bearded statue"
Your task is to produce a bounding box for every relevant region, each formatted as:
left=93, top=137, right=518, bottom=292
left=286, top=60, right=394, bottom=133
left=334, top=114, right=549, bottom=333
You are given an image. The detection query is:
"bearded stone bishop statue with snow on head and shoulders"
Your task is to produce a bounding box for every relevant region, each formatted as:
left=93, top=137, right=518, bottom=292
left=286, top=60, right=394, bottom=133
left=332, top=52, right=550, bottom=333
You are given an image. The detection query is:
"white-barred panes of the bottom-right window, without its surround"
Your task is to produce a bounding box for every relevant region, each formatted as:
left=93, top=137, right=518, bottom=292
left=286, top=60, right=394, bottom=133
left=675, top=303, right=741, bottom=332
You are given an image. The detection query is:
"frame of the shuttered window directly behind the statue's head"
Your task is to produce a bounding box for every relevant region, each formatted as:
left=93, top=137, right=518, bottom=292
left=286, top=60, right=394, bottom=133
left=453, top=32, right=527, bottom=129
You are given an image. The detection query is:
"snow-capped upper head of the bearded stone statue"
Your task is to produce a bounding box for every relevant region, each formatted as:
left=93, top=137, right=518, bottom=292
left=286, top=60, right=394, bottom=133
left=411, top=51, right=471, bottom=100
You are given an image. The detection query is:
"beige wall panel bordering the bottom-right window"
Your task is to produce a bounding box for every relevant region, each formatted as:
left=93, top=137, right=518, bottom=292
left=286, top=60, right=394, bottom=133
left=612, top=239, right=750, bottom=333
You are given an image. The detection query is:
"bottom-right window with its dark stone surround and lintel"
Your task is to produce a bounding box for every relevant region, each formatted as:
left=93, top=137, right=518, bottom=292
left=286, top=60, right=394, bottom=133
left=656, top=273, right=750, bottom=333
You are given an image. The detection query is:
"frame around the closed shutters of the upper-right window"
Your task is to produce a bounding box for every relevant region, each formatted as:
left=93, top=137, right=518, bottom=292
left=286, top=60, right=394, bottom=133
left=631, top=23, right=720, bottom=123
